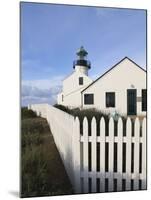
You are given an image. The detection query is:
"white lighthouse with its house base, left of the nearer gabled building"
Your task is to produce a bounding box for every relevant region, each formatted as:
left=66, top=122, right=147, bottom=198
left=57, top=46, right=92, bottom=107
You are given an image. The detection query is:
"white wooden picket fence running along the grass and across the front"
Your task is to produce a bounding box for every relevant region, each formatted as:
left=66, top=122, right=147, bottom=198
left=30, top=104, right=147, bottom=193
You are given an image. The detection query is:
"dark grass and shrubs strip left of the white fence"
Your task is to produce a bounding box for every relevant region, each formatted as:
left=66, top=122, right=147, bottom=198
left=21, top=108, right=73, bottom=197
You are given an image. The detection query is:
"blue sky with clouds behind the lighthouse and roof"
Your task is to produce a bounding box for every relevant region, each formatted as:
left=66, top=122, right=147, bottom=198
left=21, top=3, right=146, bottom=106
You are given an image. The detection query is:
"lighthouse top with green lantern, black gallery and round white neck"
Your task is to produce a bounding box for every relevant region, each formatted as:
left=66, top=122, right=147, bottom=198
left=73, top=46, right=91, bottom=76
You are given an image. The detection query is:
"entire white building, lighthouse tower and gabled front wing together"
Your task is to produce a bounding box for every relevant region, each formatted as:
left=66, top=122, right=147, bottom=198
left=58, top=47, right=147, bottom=115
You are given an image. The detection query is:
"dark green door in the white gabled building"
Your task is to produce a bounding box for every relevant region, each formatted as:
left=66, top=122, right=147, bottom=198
left=127, top=89, right=137, bottom=115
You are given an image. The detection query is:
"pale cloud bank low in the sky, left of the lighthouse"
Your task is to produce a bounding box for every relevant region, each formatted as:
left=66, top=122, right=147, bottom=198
left=21, top=76, right=64, bottom=106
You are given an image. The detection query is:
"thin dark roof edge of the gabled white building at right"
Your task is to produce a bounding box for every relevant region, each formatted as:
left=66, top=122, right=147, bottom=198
left=81, top=56, right=146, bottom=93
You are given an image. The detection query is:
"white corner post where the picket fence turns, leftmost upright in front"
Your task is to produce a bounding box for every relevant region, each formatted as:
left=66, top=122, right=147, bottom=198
left=73, top=117, right=81, bottom=194
